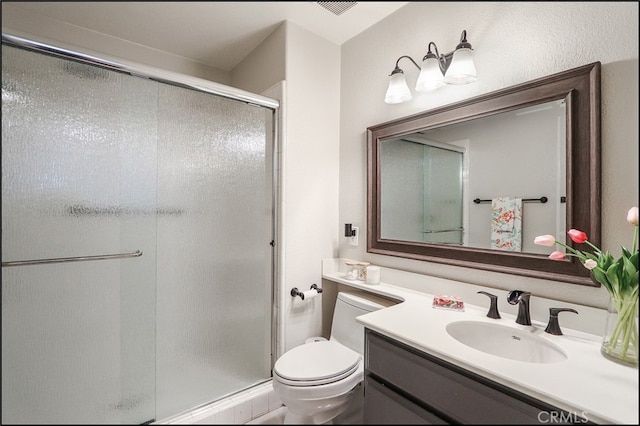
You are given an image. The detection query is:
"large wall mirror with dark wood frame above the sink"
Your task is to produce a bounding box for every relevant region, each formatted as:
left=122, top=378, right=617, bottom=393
left=367, top=62, right=601, bottom=286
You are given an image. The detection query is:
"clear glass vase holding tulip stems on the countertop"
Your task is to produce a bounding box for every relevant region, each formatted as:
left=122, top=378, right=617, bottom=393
left=600, top=293, right=638, bottom=367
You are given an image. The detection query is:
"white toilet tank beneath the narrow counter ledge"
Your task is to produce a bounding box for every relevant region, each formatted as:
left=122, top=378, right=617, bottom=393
left=330, top=292, right=398, bottom=355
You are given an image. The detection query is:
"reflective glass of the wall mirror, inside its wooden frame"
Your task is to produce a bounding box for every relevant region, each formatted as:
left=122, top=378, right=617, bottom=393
left=379, top=99, right=566, bottom=253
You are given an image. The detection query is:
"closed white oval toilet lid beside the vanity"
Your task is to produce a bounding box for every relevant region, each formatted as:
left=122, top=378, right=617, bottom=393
left=273, top=340, right=362, bottom=386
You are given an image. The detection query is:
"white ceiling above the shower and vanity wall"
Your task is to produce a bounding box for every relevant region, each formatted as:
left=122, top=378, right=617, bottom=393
left=7, top=1, right=408, bottom=71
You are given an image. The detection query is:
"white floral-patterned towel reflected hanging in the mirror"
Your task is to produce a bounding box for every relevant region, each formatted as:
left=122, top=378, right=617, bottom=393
left=491, top=197, right=522, bottom=251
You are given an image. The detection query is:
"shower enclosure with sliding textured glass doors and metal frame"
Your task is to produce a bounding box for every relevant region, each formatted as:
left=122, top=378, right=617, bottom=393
left=2, top=34, right=278, bottom=424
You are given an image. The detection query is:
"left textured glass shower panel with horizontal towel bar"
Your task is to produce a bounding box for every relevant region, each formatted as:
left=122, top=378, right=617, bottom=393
left=2, top=45, right=157, bottom=423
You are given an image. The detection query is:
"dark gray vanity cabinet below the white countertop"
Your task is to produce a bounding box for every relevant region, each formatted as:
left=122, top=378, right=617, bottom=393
left=364, top=329, right=589, bottom=424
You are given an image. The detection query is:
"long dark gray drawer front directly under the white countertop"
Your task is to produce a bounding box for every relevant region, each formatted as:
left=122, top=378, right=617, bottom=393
left=365, top=329, right=586, bottom=424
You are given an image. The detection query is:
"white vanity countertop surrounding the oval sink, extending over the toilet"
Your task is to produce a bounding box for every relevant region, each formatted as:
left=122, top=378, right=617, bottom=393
left=323, top=262, right=638, bottom=425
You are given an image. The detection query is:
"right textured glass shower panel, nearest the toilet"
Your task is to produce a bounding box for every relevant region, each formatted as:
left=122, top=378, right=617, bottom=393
left=157, top=85, right=272, bottom=418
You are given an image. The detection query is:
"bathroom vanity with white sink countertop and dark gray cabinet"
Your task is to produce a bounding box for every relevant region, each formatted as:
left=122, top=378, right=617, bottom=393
left=323, top=261, right=638, bottom=424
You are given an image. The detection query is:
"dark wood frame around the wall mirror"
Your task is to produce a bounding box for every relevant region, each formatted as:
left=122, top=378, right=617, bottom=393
left=367, top=62, right=601, bottom=286
